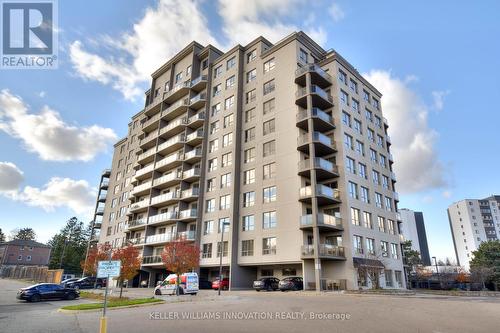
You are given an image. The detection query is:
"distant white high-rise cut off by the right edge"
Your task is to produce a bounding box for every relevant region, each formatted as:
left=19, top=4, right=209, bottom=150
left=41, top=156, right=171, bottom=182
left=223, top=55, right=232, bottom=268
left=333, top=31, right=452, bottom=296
left=448, top=195, right=500, bottom=270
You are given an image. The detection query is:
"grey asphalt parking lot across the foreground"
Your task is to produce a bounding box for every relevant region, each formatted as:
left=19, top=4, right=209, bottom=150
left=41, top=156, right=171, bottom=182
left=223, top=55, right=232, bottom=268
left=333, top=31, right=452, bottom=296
left=0, top=280, right=500, bottom=333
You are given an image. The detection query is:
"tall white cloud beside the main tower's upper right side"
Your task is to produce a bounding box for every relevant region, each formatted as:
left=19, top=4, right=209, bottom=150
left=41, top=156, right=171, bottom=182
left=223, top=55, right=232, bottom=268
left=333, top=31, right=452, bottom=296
left=364, top=70, right=447, bottom=193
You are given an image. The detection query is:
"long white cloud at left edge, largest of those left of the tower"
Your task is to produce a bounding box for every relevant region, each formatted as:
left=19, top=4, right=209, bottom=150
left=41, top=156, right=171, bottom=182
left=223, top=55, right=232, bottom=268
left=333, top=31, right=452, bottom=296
left=0, top=89, right=117, bottom=161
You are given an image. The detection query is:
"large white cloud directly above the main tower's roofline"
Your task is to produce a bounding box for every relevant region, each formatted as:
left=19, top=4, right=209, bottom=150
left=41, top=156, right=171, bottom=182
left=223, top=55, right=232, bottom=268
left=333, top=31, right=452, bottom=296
left=69, top=0, right=326, bottom=100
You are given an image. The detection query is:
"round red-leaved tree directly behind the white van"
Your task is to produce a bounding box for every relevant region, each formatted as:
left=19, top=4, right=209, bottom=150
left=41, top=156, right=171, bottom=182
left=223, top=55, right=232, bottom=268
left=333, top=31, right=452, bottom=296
left=161, top=239, right=200, bottom=295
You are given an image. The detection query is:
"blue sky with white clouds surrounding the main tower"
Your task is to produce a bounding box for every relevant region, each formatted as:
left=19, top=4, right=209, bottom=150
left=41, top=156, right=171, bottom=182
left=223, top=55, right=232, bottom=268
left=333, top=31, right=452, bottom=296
left=0, top=0, right=500, bottom=259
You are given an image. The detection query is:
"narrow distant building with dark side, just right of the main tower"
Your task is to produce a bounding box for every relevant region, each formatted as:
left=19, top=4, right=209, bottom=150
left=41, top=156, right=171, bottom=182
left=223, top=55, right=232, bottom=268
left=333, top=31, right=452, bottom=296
left=399, top=208, right=431, bottom=266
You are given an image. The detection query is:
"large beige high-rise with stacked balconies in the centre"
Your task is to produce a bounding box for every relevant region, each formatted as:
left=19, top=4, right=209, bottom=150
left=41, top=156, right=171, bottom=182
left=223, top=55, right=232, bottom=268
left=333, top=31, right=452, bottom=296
left=94, top=32, right=405, bottom=290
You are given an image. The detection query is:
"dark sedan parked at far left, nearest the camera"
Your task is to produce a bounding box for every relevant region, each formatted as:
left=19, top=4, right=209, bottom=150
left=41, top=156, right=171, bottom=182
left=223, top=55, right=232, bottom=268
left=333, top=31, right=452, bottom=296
left=16, top=283, right=80, bottom=302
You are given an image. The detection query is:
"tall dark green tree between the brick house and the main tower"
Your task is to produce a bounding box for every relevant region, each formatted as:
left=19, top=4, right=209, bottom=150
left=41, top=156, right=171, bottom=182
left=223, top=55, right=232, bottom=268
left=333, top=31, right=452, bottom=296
left=48, top=217, right=90, bottom=274
